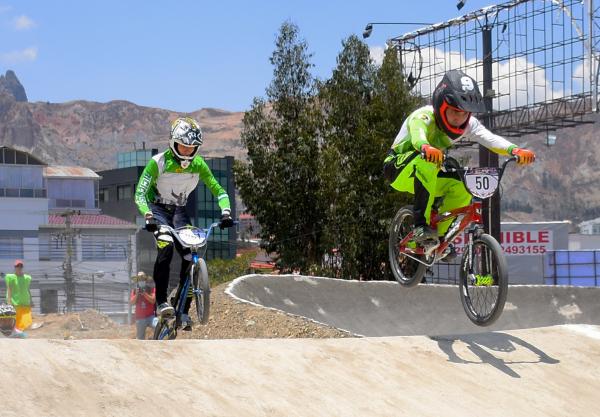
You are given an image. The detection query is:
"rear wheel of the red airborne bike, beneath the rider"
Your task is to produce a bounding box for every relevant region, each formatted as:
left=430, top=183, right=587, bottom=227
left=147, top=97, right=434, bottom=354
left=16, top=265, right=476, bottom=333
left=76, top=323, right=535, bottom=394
left=389, top=206, right=426, bottom=287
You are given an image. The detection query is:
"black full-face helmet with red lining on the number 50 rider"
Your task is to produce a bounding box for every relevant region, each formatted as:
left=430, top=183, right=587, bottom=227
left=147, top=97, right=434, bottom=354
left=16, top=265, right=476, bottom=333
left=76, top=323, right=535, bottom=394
left=431, top=70, right=485, bottom=139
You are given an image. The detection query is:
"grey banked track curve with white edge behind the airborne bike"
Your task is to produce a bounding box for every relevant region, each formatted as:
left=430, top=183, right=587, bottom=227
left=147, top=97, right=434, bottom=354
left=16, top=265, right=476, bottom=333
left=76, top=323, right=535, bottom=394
left=226, top=275, right=600, bottom=336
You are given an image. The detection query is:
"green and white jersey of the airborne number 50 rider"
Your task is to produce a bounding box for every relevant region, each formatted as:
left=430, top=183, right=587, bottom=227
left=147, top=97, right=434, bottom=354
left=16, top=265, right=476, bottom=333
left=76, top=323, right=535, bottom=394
left=392, top=106, right=517, bottom=155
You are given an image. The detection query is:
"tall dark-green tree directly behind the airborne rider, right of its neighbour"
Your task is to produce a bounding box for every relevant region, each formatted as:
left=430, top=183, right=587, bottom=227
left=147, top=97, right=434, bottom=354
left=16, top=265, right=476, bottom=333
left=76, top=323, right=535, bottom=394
left=320, top=36, right=418, bottom=279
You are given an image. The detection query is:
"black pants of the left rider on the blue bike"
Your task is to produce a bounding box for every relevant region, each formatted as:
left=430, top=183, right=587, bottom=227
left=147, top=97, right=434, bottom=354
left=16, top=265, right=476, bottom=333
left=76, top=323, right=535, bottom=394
left=150, top=204, right=192, bottom=313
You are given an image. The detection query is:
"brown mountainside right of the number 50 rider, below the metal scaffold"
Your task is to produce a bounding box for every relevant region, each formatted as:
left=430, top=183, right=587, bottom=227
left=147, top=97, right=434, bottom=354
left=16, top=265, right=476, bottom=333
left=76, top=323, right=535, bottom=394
left=502, top=113, right=600, bottom=224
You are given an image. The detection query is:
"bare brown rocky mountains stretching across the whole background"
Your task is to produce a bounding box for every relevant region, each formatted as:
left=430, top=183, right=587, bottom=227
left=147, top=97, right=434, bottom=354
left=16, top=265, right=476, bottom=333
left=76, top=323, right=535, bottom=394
left=0, top=71, right=600, bottom=223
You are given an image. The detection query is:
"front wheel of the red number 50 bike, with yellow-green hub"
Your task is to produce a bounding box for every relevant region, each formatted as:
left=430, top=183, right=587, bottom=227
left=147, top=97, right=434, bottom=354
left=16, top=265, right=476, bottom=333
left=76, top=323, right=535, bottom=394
left=459, top=234, right=508, bottom=326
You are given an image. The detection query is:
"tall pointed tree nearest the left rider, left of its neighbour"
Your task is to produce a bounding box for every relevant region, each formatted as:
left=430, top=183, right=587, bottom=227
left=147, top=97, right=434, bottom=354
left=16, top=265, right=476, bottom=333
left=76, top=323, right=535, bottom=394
left=235, top=22, right=323, bottom=271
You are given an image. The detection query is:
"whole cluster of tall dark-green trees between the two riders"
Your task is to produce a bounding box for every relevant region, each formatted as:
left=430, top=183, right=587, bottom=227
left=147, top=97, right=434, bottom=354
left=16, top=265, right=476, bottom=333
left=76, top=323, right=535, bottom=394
left=235, top=23, right=420, bottom=279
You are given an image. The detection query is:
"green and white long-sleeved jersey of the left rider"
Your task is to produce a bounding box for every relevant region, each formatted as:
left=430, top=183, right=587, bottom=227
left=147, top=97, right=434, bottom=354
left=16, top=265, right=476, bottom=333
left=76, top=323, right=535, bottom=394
left=135, top=150, right=231, bottom=215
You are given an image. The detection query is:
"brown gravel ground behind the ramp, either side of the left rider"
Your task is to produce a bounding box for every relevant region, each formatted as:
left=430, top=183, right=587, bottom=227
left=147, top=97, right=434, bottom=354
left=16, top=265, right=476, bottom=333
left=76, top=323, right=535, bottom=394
left=27, top=283, right=351, bottom=339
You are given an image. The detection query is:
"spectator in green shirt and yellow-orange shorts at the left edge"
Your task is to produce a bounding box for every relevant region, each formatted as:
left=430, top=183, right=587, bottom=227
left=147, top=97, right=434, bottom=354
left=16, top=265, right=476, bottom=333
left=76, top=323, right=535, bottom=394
left=4, top=259, right=32, bottom=331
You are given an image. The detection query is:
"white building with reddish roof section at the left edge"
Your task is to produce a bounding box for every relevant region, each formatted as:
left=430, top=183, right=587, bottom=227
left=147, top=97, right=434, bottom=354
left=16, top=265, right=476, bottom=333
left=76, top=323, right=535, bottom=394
left=0, top=147, right=137, bottom=312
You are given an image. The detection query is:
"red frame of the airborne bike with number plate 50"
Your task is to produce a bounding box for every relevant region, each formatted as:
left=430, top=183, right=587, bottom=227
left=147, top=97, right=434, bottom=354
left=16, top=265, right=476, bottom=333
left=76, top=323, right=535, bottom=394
left=398, top=157, right=516, bottom=267
